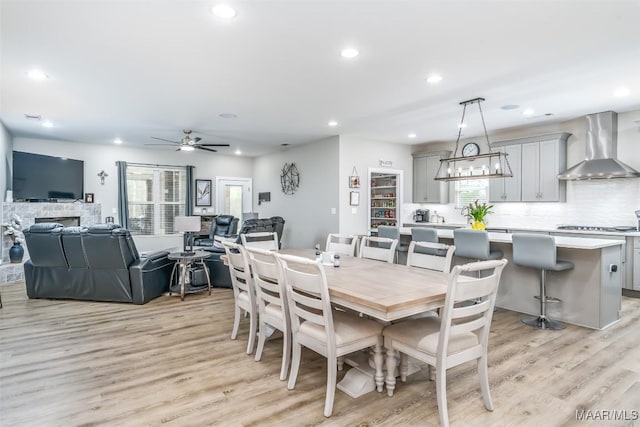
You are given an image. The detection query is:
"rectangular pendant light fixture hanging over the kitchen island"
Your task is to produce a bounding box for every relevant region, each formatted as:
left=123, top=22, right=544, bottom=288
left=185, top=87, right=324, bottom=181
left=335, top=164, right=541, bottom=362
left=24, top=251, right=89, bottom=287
left=434, top=98, right=513, bottom=181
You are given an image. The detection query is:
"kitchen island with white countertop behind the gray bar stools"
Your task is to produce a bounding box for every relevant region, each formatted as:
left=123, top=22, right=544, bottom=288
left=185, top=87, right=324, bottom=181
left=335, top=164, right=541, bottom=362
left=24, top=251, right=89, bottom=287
left=401, top=228, right=624, bottom=329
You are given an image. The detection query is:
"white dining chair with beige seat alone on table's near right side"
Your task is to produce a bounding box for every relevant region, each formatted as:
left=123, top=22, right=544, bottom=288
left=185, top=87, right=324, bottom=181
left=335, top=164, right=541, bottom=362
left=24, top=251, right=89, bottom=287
left=383, top=259, right=507, bottom=426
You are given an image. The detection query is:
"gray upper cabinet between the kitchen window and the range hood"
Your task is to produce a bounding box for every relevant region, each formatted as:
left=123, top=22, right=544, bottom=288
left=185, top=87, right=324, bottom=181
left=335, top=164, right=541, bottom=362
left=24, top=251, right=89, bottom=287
left=489, top=132, right=571, bottom=202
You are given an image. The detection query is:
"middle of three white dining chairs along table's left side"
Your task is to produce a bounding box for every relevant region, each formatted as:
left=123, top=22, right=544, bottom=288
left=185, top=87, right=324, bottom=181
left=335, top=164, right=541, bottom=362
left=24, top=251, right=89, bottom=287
left=247, top=247, right=291, bottom=381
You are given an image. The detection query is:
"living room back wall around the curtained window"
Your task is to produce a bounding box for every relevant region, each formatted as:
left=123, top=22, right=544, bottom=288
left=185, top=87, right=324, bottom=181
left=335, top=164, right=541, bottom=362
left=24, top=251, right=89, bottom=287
left=13, top=138, right=253, bottom=251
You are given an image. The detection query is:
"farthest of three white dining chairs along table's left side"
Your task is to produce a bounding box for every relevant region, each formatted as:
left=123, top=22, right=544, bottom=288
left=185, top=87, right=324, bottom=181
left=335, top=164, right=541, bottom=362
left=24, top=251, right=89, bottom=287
left=222, top=242, right=258, bottom=354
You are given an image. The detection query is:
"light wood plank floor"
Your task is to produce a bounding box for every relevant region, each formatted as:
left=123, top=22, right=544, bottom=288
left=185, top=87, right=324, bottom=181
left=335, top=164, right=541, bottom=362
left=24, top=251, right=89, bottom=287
left=0, top=282, right=640, bottom=427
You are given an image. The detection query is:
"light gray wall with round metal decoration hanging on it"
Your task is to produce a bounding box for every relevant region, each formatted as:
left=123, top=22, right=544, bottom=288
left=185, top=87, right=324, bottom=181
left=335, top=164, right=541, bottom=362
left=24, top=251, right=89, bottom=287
left=253, top=137, right=340, bottom=248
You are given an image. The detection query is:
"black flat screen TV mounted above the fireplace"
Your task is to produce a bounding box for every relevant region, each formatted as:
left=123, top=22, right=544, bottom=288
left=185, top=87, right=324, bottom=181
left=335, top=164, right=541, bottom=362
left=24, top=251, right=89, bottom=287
left=12, top=151, right=84, bottom=202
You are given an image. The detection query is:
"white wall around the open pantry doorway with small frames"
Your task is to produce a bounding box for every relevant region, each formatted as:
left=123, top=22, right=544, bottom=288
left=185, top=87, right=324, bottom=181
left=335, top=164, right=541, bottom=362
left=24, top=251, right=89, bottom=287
left=338, top=136, right=413, bottom=234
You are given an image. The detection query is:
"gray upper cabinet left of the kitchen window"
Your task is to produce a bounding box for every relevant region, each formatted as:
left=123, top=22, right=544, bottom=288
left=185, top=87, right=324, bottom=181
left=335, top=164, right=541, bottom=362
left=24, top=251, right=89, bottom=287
left=413, top=151, right=451, bottom=203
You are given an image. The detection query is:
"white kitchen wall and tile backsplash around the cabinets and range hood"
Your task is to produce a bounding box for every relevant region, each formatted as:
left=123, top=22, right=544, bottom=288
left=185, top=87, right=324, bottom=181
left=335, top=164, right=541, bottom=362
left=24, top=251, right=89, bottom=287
left=403, top=110, right=640, bottom=227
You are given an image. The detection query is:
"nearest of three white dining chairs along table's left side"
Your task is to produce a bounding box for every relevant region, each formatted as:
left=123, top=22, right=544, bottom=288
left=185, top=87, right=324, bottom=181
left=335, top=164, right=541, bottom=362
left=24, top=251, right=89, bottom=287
left=276, top=254, right=382, bottom=417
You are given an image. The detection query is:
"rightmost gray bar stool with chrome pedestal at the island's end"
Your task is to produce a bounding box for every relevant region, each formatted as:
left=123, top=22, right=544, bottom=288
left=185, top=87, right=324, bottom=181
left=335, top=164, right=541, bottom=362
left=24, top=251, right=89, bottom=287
left=512, top=233, right=573, bottom=329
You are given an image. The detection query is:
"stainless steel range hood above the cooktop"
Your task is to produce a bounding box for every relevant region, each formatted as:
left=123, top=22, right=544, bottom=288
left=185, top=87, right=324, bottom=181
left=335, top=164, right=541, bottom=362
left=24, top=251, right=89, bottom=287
left=558, top=111, right=640, bottom=180
